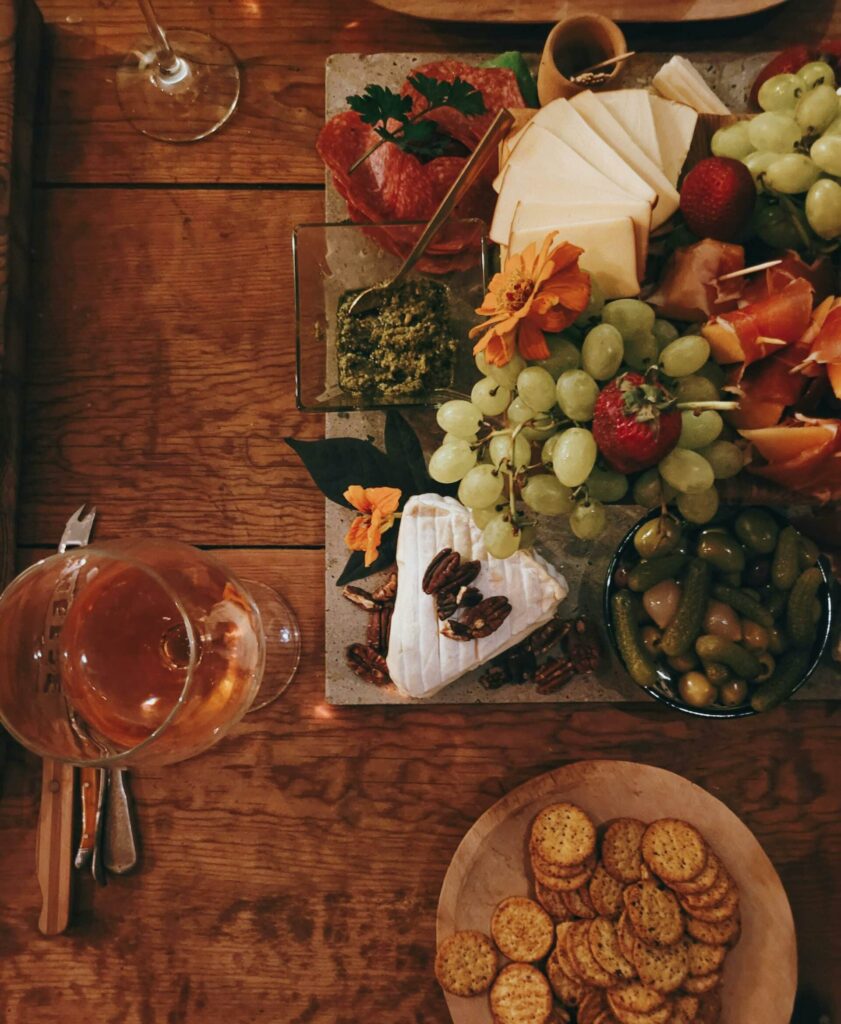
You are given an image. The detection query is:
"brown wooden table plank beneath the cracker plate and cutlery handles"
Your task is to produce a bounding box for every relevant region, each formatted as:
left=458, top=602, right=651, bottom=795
left=0, top=551, right=841, bottom=1024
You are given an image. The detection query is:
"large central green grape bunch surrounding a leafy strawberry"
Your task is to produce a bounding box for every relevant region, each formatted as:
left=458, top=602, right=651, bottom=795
left=429, top=281, right=743, bottom=558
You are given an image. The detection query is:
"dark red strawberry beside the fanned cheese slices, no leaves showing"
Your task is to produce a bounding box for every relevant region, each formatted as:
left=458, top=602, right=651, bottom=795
left=680, top=157, right=756, bottom=242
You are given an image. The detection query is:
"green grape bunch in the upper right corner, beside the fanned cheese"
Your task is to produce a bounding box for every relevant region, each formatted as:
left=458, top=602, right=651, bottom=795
left=711, top=60, right=841, bottom=250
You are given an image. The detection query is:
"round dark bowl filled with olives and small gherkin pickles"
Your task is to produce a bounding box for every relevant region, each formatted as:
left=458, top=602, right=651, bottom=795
left=604, top=507, right=832, bottom=718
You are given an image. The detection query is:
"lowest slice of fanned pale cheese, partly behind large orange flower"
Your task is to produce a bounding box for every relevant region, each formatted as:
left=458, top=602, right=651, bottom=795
left=508, top=217, right=639, bottom=299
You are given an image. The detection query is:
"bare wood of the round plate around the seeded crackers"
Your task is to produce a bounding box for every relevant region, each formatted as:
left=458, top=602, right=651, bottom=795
left=437, top=761, right=797, bottom=1024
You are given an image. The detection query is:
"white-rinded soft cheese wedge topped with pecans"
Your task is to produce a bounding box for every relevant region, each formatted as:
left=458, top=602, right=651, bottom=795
left=387, top=495, right=569, bottom=697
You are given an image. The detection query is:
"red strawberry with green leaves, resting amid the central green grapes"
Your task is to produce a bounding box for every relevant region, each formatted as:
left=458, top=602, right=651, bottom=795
left=593, top=372, right=680, bottom=473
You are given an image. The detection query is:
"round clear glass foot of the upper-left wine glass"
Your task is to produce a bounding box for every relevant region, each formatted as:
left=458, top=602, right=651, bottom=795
left=117, top=29, right=240, bottom=142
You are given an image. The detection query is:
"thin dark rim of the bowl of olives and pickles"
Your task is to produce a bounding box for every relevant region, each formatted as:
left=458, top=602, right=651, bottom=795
left=602, top=504, right=833, bottom=719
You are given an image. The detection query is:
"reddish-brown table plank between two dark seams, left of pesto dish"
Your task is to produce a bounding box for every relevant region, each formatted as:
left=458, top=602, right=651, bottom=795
left=19, top=188, right=324, bottom=546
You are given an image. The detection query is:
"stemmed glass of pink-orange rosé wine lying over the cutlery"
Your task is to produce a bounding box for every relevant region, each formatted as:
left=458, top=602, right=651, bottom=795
left=0, top=539, right=300, bottom=766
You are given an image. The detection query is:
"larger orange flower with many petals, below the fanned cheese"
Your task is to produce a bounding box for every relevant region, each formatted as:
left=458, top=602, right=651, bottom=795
left=470, top=231, right=590, bottom=367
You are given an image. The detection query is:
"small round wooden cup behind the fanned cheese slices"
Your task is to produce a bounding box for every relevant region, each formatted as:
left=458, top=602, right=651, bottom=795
left=538, top=14, right=628, bottom=106
